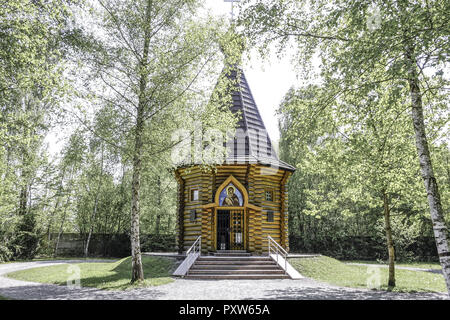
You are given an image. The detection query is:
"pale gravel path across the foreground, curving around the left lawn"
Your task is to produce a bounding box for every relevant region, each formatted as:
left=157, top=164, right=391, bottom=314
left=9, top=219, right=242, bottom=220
left=0, top=260, right=448, bottom=300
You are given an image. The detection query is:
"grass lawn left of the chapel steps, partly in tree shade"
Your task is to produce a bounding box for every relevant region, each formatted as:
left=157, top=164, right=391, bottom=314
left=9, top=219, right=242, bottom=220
left=7, top=256, right=175, bottom=290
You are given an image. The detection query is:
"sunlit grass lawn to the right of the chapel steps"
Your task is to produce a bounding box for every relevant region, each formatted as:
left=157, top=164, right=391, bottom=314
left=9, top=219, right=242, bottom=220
left=289, top=256, right=447, bottom=292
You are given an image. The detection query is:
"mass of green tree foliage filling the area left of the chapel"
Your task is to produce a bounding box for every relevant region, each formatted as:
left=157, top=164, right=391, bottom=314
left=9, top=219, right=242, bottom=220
left=0, top=0, right=243, bottom=260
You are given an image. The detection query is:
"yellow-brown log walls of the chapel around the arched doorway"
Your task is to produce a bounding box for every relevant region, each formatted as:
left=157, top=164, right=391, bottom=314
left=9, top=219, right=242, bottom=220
left=176, top=164, right=291, bottom=254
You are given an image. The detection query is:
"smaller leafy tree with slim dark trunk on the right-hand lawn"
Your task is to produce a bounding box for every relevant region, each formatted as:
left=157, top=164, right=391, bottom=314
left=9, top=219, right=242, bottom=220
left=279, top=80, right=423, bottom=288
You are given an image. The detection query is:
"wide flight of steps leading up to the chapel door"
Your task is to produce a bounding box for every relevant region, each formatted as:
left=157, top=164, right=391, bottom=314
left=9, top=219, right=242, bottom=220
left=185, top=250, right=290, bottom=280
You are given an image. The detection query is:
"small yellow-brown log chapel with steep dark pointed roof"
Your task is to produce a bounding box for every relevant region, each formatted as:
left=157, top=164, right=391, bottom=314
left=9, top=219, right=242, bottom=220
left=175, top=61, right=295, bottom=255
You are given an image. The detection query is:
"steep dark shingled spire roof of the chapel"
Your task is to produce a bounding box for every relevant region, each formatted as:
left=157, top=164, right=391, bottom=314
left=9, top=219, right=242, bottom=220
left=226, top=69, right=295, bottom=171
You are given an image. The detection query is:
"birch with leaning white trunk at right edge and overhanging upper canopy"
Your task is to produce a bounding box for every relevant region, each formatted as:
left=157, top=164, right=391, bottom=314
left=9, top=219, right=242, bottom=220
left=240, top=0, right=450, bottom=292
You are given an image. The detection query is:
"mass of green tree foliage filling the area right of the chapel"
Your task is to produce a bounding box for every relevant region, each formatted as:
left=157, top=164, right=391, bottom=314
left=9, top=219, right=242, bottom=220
left=243, top=0, right=450, bottom=264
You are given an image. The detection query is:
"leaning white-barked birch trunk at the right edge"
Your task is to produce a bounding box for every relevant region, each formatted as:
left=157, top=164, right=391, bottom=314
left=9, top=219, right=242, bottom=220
left=405, top=47, right=450, bottom=294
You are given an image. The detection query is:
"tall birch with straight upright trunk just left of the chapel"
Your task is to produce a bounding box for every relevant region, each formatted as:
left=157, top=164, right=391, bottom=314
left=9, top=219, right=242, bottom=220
left=74, top=0, right=234, bottom=282
